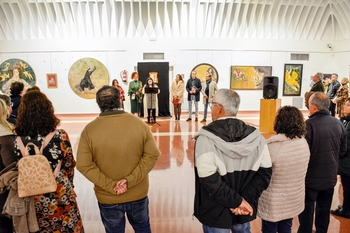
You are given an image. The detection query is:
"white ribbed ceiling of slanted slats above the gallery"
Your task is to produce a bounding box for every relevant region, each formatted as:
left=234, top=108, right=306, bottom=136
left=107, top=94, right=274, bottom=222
left=0, top=0, right=350, bottom=41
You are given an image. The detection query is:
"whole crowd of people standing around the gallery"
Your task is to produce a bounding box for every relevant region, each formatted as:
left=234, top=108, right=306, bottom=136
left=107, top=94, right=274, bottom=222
left=0, top=71, right=350, bottom=233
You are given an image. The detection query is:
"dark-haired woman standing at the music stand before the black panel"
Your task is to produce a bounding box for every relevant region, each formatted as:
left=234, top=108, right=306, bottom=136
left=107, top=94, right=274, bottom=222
left=142, top=77, right=160, bottom=124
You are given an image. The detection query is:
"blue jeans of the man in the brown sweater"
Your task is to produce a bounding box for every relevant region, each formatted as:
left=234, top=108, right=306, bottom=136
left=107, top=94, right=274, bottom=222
left=98, top=197, right=151, bottom=233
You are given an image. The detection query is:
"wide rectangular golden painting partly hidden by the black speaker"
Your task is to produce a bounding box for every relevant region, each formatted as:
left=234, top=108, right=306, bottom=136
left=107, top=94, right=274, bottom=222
left=230, top=66, right=272, bottom=90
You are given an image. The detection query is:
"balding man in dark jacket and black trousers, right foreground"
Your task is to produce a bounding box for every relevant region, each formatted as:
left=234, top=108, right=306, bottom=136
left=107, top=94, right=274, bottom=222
left=298, top=92, right=347, bottom=233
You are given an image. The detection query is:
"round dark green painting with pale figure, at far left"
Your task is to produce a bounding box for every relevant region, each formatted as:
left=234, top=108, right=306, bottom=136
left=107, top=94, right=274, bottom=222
left=0, top=58, right=36, bottom=95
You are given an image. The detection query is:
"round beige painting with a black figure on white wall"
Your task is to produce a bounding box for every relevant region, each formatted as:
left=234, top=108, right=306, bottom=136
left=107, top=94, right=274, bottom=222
left=68, top=58, right=109, bottom=99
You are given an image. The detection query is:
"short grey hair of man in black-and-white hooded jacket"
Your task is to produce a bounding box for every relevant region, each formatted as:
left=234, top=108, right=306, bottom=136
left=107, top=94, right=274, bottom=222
left=215, top=89, right=241, bottom=116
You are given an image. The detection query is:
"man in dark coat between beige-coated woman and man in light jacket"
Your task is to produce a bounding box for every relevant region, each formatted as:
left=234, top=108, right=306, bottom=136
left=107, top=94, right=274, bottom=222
left=186, top=70, right=202, bottom=121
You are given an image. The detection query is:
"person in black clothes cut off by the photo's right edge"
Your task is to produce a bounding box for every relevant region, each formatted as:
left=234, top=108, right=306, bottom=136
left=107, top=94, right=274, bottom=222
left=331, top=98, right=350, bottom=218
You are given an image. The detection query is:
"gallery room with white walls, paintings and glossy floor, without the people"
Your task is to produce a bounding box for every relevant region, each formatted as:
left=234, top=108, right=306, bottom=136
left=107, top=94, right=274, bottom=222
left=0, top=0, right=350, bottom=233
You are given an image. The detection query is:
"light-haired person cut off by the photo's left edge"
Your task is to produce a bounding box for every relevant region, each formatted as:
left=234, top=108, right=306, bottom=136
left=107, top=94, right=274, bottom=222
left=0, top=99, right=17, bottom=233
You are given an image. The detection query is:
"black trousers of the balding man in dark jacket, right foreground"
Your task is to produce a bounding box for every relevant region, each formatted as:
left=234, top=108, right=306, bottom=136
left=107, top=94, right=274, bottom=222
left=298, top=188, right=334, bottom=233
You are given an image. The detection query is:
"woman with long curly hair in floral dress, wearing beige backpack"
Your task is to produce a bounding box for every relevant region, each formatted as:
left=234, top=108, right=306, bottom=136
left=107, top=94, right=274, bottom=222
left=15, top=91, right=84, bottom=233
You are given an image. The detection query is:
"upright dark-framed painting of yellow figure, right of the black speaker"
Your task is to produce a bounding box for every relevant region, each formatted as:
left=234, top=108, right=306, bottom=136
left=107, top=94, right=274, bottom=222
left=283, top=64, right=303, bottom=96
